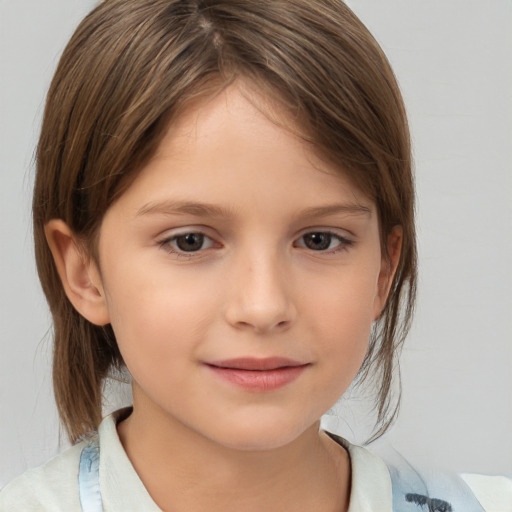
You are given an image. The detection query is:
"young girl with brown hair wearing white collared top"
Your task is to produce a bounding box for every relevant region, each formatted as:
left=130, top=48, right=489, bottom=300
left=0, top=0, right=511, bottom=512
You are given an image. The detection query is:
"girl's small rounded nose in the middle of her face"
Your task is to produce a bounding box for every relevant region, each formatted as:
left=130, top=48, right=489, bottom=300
left=226, top=251, right=297, bottom=334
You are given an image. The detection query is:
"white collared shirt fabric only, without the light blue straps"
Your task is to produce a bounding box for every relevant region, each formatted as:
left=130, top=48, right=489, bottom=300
left=0, top=411, right=512, bottom=512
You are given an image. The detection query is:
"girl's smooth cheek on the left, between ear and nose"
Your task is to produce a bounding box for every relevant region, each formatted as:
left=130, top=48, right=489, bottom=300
left=101, top=267, right=215, bottom=377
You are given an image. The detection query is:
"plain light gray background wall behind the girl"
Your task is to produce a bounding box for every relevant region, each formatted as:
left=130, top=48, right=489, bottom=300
left=0, top=0, right=512, bottom=487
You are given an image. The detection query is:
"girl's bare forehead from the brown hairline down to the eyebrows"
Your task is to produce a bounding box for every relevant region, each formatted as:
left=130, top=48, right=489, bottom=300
left=119, top=83, right=370, bottom=214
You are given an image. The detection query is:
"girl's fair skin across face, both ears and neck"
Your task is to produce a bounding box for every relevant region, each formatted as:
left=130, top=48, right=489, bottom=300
left=46, top=84, right=401, bottom=512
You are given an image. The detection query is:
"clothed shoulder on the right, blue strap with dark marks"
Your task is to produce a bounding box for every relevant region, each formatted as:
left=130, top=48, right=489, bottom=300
left=329, top=434, right=512, bottom=512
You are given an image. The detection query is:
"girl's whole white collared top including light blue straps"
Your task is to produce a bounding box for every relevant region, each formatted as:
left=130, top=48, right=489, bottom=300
left=0, top=410, right=512, bottom=512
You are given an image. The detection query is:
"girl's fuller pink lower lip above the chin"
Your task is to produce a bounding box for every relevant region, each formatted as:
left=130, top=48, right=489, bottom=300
left=208, top=365, right=308, bottom=393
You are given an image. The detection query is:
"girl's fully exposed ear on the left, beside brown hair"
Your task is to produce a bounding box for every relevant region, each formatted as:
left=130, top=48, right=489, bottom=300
left=45, top=219, right=110, bottom=325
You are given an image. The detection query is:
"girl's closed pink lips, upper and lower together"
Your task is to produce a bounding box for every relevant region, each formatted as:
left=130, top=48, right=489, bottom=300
left=206, top=357, right=309, bottom=392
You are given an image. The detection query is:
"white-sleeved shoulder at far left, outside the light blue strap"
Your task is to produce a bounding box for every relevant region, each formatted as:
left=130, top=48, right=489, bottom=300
left=0, top=443, right=85, bottom=512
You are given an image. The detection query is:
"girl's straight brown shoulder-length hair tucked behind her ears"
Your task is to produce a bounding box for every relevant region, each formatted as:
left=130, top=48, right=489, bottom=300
left=33, top=0, right=416, bottom=442
